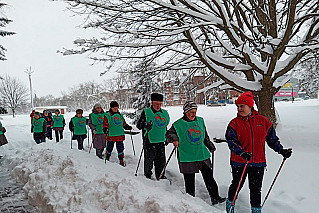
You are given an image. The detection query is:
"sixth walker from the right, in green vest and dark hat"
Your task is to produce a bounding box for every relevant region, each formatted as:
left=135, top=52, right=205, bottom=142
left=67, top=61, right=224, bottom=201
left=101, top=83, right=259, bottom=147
left=69, top=109, right=88, bottom=150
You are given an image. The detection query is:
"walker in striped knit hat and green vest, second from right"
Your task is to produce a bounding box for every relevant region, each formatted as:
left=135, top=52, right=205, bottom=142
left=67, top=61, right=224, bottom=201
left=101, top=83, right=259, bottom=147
left=166, top=101, right=226, bottom=205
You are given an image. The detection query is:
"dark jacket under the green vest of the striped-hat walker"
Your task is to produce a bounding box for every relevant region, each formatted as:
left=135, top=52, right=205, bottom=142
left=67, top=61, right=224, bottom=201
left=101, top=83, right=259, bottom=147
left=165, top=114, right=216, bottom=174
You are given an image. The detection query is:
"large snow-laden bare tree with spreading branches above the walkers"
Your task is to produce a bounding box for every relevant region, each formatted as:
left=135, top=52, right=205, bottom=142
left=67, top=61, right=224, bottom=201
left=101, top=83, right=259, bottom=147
left=63, top=0, right=319, bottom=122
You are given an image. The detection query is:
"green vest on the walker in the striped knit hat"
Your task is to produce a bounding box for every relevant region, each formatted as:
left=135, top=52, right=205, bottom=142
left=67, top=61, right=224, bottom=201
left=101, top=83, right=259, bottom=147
left=173, top=117, right=210, bottom=162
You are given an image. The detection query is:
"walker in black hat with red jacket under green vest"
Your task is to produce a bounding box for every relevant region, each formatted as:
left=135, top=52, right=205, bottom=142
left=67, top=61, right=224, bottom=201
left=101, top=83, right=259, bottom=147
left=103, top=101, right=132, bottom=166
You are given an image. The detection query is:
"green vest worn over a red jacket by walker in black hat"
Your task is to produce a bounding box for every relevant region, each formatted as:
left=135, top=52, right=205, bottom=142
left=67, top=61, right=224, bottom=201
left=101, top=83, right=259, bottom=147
left=106, top=112, right=125, bottom=136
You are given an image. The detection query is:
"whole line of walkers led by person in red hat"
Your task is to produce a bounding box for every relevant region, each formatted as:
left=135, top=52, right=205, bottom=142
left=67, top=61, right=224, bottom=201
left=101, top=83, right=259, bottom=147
left=26, top=92, right=292, bottom=213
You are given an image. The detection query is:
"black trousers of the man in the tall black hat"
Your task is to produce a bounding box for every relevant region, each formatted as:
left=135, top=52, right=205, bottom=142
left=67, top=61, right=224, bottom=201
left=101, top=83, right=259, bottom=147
left=144, top=143, right=166, bottom=179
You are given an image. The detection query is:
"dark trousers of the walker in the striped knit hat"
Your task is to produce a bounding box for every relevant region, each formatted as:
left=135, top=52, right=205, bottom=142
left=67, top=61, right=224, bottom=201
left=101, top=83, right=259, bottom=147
left=183, top=162, right=219, bottom=199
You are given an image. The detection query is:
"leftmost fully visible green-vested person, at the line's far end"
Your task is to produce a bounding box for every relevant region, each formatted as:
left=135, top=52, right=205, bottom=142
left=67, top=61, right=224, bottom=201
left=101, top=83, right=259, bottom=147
left=31, top=112, right=47, bottom=144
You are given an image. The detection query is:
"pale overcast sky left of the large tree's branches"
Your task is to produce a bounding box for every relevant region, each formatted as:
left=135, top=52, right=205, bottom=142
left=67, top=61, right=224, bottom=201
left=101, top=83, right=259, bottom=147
left=0, top=0, right=112, bottom=97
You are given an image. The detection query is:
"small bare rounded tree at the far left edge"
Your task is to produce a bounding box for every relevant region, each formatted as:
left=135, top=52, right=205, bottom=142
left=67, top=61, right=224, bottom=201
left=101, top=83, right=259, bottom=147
left=0, top=75, right=29, bottom=117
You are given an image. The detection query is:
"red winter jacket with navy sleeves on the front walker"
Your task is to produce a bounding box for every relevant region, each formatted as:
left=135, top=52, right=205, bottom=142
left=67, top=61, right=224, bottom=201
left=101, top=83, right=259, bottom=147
left=225, top=110, right=283, bottom=167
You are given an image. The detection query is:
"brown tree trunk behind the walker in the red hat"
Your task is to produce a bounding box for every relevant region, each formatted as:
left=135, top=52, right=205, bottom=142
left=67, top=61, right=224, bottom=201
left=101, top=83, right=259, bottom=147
left=254, top=88, right=277, bottom=128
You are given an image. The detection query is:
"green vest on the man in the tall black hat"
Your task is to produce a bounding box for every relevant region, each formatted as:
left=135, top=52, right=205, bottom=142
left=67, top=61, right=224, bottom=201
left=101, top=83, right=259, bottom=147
left=144, top=108, right=170, bottom=143
